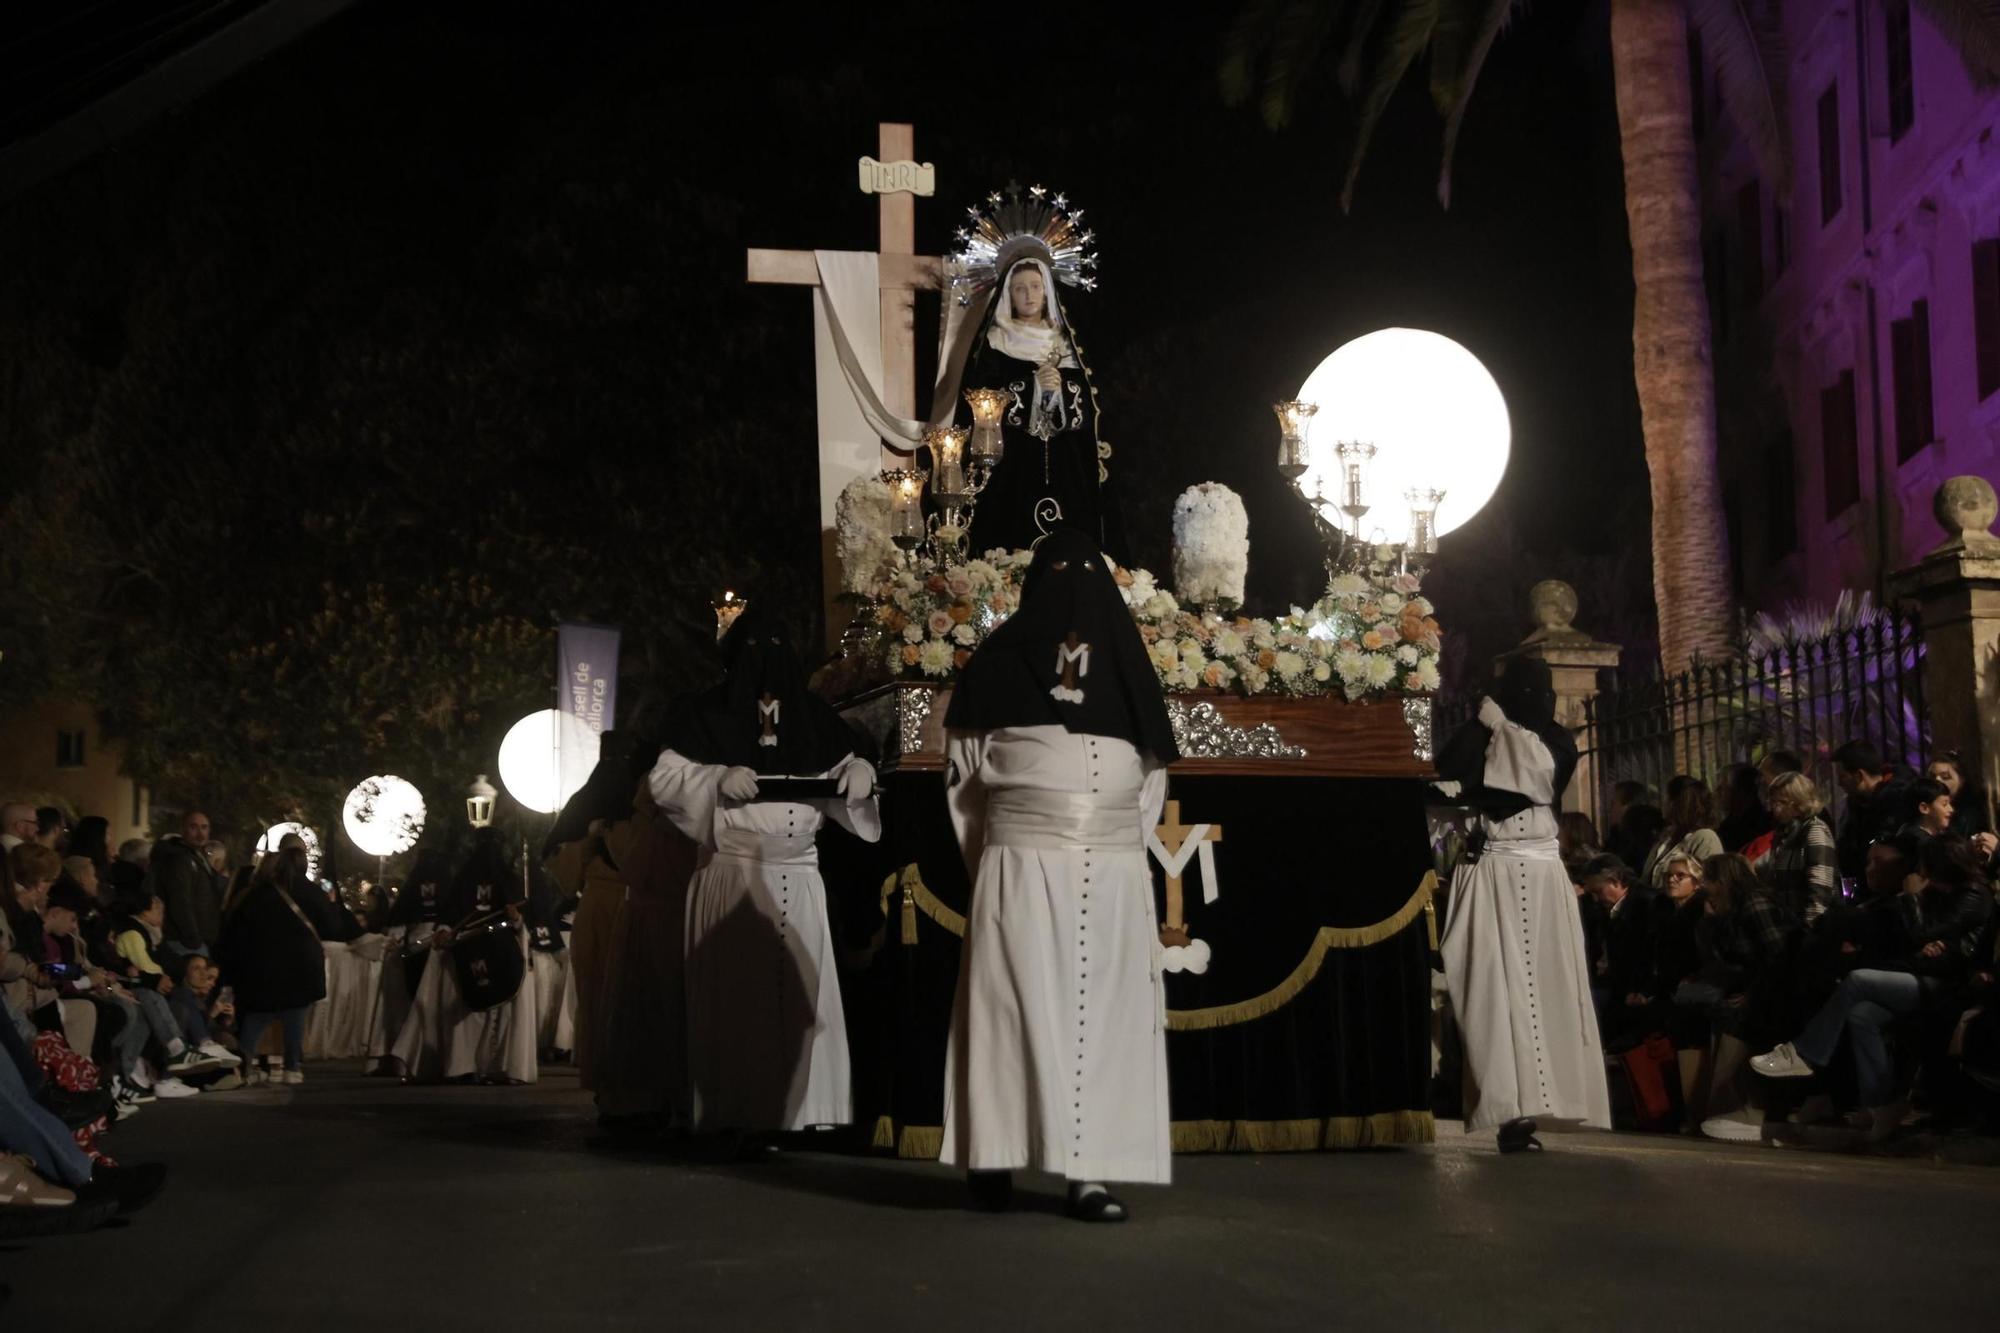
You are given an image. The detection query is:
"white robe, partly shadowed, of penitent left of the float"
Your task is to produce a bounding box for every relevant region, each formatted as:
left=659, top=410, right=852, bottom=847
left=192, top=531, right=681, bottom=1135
left=648, top=751, right=882, bottom=1131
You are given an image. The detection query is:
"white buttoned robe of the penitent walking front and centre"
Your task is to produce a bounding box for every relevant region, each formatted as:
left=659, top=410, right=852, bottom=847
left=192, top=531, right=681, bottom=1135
left=940, top=725, right=1172, bottom=1185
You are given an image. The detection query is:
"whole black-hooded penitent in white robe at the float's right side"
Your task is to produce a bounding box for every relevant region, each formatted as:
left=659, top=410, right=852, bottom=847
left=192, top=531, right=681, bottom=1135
left=1438, top=656, right=1610, bottom=1153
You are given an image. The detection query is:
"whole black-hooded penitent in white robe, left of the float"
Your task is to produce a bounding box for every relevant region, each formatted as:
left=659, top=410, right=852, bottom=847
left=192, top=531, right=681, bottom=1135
left=646, top=600, right=882, bottom=1149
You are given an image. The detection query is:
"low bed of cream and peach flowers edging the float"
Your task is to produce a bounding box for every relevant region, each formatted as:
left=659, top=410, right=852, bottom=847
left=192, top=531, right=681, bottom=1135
left=828, top=550, right=1442, bottom=699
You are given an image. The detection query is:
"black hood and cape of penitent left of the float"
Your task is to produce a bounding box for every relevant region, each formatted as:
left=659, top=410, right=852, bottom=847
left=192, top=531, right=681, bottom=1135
left=666, top=604, right=858, bottom=777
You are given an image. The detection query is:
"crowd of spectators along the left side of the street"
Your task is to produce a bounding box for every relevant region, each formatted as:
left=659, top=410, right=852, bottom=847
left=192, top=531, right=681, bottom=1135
left=0, top=803, right=358, bottom=1239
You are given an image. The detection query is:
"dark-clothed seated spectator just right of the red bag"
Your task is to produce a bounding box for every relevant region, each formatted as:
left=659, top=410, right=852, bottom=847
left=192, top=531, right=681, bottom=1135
left=1674, top=853, right=1800, bottom=1143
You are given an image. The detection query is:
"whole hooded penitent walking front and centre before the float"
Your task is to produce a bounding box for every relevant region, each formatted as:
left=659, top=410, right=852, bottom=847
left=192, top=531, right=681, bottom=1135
left=942, top=526, right=1178, bottom=1221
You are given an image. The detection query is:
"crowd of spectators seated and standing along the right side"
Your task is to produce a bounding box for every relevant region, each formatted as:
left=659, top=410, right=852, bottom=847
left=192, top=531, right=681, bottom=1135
left=1560, top=741, right=2000, bottom=1143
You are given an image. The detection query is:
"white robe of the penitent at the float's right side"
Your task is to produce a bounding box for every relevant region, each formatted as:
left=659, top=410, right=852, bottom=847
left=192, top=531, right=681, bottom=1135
left=1442, top=723, right=1612, bottom=1129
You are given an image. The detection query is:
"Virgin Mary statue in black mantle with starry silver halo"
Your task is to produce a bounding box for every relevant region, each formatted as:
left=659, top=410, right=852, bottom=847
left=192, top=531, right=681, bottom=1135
left=948, top=188, right=1118, bottom=554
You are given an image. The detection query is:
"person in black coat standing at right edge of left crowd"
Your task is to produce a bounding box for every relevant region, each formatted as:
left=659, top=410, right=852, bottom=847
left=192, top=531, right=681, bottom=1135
left=220, top=833, right=326, bottom=1083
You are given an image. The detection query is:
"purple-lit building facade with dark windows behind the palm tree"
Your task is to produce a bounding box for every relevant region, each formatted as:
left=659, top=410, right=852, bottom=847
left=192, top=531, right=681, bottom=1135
left=1696, top=0, right=2000, bottom=608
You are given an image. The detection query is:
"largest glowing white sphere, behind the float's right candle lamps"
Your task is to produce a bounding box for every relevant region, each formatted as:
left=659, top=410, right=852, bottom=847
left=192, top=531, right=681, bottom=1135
left=1298, top=328, right=1512, bottom=542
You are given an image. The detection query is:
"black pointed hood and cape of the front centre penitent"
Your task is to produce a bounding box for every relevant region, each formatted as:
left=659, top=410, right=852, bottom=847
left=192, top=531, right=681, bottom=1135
left=944, top=526, right=1180, bottom=765
